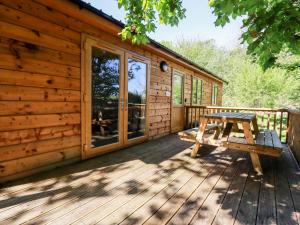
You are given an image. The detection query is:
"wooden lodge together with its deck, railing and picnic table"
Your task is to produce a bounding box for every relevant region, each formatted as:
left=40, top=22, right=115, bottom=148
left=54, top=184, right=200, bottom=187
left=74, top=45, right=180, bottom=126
left=0, top=0, right=300, bottom=225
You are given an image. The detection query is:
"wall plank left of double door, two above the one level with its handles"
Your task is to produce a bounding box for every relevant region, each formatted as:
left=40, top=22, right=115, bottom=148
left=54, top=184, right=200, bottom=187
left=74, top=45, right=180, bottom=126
left=0, top=69, right=80, bottom=90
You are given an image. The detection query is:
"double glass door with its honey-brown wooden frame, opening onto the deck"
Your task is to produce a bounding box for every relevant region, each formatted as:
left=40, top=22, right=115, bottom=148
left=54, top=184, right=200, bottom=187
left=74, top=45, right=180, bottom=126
left=82, top=39, right=149, bottom=157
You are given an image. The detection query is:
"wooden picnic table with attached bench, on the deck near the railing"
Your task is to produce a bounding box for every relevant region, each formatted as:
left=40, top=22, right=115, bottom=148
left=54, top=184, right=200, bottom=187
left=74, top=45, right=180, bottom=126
left=191, top=112, right=282, bottom=174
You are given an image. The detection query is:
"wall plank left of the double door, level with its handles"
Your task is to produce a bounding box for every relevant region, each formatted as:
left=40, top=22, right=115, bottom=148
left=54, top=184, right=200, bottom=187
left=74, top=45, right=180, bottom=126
left=0, top=101, right=80, bottom=116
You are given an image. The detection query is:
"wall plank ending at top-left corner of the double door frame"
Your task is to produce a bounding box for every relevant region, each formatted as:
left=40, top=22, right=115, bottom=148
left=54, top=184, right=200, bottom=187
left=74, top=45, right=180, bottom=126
left=0, top=5, right=80, bottom=44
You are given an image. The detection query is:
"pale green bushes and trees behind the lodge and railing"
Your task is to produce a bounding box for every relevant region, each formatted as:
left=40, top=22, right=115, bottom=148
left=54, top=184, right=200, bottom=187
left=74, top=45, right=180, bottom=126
left=163, top=40, right=300, bottom=108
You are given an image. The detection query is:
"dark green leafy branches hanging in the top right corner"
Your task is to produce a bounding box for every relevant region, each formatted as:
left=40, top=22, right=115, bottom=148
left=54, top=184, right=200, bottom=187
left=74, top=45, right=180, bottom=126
left=209, top=0, right=300, bottom=69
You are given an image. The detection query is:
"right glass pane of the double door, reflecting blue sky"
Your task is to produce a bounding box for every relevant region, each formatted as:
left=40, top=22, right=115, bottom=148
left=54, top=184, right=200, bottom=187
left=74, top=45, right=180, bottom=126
left=127, top=59, right=147, bottom=139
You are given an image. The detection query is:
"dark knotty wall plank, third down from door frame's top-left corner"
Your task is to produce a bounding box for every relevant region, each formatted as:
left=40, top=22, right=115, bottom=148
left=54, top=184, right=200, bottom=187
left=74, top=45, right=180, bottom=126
left=0, top=37, right=80, bottom=67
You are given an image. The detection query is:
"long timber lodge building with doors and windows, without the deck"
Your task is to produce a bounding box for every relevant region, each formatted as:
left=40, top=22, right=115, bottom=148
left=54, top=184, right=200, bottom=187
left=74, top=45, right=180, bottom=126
left=0, top=0, right=223, bottom=182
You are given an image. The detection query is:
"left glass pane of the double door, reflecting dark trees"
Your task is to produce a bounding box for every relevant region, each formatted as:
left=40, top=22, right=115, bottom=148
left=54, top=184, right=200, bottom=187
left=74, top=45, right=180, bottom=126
left=91, top=48, right=120, bottom=147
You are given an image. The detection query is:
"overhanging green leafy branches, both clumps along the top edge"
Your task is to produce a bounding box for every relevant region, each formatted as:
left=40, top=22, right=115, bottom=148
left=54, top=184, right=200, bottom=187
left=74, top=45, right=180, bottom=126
left=118, top=0, right=300, bottom=69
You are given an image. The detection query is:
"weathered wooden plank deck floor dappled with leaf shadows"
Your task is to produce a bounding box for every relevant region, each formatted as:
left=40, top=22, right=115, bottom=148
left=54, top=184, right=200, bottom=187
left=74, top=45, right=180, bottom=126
left=0, top=135, right=300, bottom=225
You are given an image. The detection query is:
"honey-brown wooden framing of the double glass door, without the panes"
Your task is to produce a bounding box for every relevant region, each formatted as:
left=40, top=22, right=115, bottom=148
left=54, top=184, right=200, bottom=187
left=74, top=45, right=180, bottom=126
left=80, top=34, right=151, bottom=159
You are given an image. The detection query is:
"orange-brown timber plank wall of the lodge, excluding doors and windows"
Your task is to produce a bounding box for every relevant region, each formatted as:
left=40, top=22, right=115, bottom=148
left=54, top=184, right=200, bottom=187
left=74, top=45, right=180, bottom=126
left=0, top=0, right=222, bottom=182
